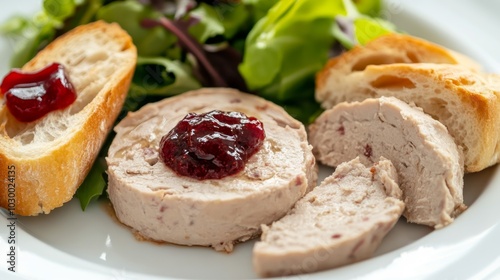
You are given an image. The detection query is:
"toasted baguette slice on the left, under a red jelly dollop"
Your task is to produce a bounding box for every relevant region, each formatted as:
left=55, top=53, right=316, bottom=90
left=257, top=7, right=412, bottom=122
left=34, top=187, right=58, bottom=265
left=0, top=21, right=137, bottom=215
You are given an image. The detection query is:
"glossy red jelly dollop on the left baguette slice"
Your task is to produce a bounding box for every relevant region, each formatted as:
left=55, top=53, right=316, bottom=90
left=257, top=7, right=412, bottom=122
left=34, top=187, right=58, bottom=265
left=0, top=63, right=76, bottom=122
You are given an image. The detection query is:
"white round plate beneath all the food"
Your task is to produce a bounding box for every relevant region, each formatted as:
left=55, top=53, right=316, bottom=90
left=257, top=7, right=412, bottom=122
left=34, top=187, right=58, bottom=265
left=0, top=0, right=500, bottom=279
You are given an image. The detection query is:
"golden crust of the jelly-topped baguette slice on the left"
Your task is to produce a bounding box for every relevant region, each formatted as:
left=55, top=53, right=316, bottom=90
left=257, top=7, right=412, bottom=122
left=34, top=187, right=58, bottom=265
left=0, top=21, right=137, bottom=216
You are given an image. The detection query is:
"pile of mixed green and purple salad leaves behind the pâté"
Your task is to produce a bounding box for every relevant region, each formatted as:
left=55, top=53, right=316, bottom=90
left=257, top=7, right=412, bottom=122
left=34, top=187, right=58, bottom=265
left=0, top=0, right=395, bottom=209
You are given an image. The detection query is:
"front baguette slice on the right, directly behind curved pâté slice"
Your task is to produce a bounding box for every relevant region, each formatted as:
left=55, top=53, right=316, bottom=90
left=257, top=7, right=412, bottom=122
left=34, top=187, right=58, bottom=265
left=316, top=63, right=500, bottom=172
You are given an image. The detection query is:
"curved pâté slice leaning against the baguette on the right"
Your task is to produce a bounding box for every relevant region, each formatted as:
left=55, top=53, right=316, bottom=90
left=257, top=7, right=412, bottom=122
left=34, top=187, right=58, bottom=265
left=309, top=97, right=466, bottom=228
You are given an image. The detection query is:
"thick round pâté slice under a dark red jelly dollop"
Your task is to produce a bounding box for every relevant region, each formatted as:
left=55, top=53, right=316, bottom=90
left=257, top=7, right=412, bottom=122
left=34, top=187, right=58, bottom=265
left=107, top=88, right=317, bottom=252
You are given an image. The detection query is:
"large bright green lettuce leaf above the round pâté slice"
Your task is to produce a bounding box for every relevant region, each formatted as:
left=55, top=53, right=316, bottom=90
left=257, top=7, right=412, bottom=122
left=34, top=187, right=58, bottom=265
left=239, top=0, right=346, bottom=101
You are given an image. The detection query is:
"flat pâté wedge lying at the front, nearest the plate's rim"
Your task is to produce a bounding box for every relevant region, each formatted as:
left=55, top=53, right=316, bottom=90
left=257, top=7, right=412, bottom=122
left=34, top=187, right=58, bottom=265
left=253, top=158, right=404, bottom=277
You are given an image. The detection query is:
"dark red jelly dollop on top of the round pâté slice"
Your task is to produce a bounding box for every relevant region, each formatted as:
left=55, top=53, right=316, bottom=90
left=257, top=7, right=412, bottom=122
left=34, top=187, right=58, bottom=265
left=160, top=110, right=265, bottom=180
